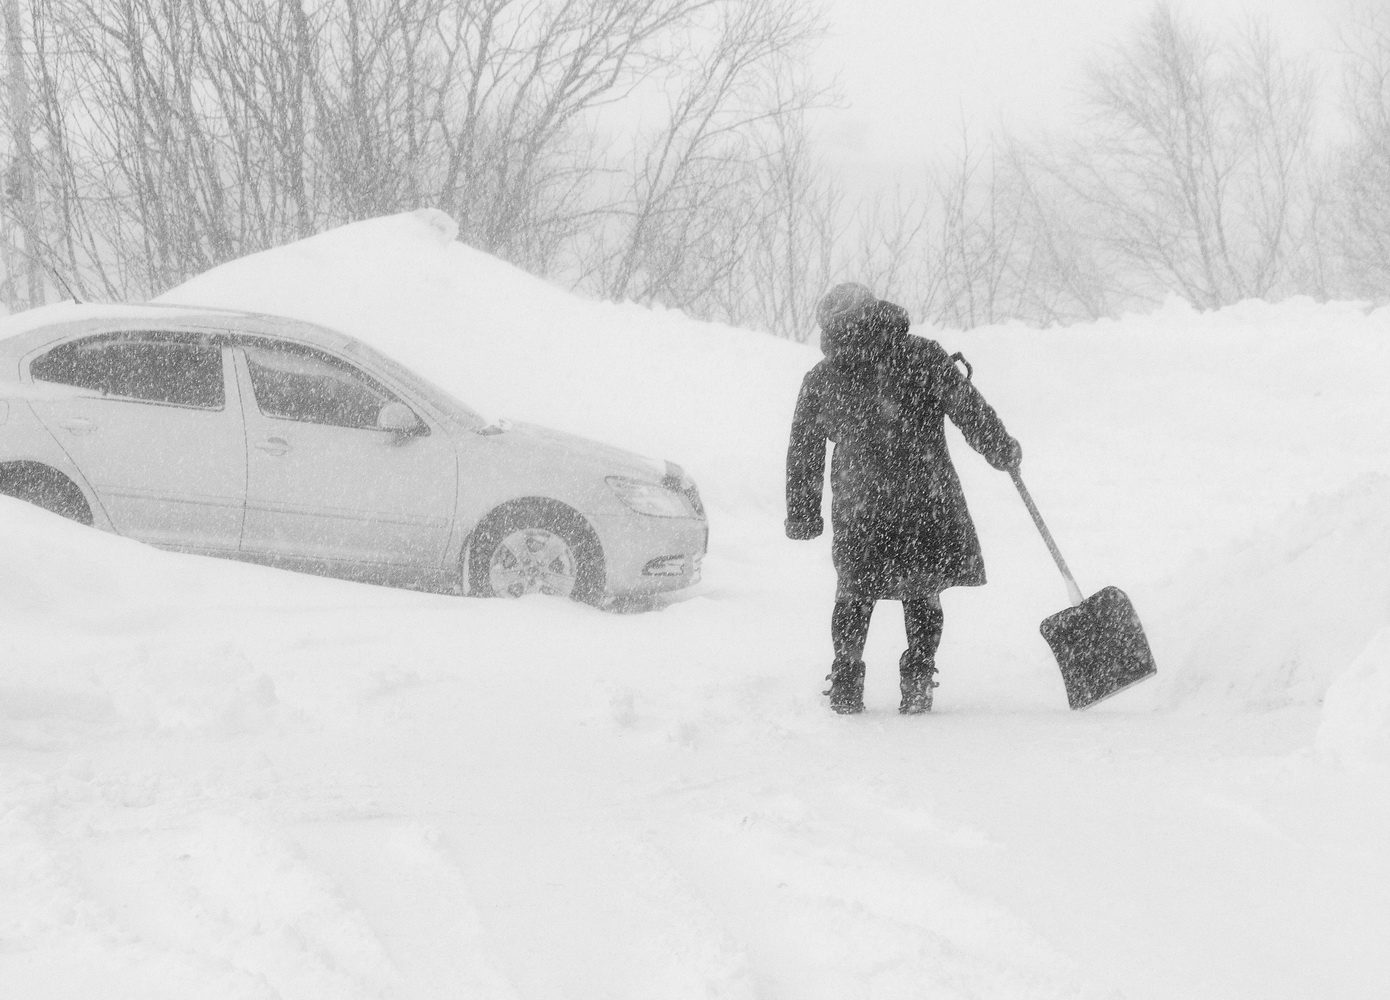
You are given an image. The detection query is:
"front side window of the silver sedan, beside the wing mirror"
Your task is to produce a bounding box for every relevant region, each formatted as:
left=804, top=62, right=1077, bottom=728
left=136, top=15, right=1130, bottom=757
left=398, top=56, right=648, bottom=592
left=242, top=342, right=398, bottom=430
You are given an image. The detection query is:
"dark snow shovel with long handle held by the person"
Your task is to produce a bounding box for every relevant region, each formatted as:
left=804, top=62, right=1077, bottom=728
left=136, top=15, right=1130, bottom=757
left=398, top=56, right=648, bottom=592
left=1009, top=469, right=1158, bottom=708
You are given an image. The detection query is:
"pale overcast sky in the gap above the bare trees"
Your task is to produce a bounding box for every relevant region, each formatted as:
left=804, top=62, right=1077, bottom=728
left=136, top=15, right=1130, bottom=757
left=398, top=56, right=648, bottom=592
left=819, top=0, right=1347, bottom=181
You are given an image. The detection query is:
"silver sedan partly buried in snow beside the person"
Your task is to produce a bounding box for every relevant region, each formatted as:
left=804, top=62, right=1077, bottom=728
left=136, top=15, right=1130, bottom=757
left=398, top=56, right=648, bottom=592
left=0, top=305, right=709, bottom=604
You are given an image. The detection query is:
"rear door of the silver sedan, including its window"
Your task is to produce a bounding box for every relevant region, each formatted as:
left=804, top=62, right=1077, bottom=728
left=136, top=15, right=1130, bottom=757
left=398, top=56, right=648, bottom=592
left=29, top=331, right=246, bottom=552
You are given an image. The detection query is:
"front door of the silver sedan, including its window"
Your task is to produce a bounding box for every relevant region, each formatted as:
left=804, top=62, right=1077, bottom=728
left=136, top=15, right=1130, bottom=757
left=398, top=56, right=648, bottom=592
left=236, top=338, right=457, bottom=567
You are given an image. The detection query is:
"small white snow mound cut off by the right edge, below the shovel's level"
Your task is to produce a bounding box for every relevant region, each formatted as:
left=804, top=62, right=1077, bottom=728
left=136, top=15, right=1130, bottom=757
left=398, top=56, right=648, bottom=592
left=1316, top=627, right=1390, bottom=772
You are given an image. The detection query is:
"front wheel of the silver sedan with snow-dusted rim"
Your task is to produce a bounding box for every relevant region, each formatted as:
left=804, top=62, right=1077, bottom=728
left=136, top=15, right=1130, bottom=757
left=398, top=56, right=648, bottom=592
left=468, top=501, right=603, bottom=605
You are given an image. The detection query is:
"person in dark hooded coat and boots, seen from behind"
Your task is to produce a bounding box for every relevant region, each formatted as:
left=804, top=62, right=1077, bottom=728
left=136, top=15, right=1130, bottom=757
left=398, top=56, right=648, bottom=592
left=787, top=282, right=1022, bottom=713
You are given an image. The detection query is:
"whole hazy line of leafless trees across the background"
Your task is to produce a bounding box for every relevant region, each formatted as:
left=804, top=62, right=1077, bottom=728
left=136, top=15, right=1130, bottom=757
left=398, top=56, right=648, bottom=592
left=0, top=0, right=1334, bottom=331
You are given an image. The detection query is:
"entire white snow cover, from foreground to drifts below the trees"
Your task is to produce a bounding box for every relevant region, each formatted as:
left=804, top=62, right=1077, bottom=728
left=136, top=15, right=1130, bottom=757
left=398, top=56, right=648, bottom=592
left=0, top=213, right=1390, bottom=1000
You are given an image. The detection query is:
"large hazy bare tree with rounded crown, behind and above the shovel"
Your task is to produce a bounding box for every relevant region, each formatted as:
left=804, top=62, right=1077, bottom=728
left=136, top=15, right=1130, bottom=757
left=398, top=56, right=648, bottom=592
left=1055, top=3, right=1314, bottom=306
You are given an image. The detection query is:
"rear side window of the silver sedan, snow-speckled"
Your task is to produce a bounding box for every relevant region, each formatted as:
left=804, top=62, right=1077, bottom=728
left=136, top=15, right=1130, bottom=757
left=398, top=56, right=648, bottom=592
left=29, top=332, right=227, bottom=410
